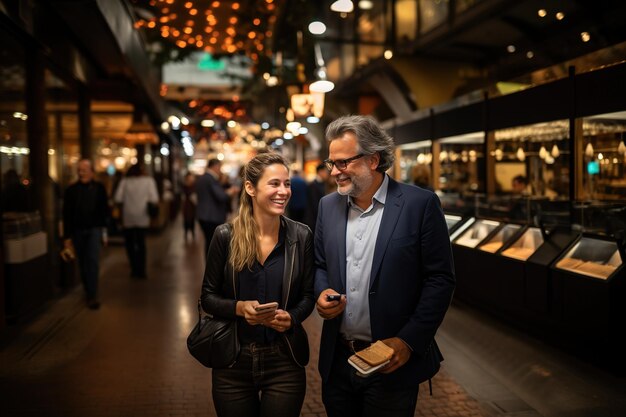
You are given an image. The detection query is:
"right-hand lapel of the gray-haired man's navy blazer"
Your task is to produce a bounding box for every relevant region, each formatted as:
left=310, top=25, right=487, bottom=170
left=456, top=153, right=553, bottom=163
left=368, top=178, right=404, bottom=289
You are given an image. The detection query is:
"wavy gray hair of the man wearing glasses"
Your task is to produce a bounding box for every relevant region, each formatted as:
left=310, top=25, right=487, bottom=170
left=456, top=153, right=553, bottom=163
left=326, top=115, right=395, bottom=172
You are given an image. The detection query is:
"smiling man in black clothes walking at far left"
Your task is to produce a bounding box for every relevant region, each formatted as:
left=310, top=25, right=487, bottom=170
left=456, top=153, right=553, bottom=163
left=63, top=159, right=109, bottom=310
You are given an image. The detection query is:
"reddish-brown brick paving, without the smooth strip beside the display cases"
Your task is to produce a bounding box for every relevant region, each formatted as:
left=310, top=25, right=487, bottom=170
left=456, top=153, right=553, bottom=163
left=0, top=219, right=488, bottom=417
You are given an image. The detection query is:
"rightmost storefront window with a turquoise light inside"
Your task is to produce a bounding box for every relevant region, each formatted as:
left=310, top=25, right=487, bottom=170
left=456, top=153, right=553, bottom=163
left=581, top=112, right=626, bottom=200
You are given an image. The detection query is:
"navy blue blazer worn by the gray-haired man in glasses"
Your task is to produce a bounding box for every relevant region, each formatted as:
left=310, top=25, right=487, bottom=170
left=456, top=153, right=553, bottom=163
left=315, top=178, right=455, bottom=385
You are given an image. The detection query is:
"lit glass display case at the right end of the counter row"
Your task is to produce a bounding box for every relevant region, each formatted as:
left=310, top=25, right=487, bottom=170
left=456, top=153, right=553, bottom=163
left=555, top=237, right=623, bottom=280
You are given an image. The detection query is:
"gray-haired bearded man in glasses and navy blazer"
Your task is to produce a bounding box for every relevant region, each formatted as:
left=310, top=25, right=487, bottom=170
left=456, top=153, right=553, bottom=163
left=315, top=116, right=455, bottom=417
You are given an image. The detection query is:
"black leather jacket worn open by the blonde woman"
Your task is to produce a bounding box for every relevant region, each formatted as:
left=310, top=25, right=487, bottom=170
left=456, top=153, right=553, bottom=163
left=201, top=217, right=315, bottom=366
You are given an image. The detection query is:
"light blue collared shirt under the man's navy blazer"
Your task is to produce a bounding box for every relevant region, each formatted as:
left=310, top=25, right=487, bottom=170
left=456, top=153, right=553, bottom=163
left=340, top=174, right=389, bottom=341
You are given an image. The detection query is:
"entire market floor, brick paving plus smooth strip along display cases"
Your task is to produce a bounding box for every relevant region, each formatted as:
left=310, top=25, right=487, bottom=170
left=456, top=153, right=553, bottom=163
left=0, top=218, right=626, bottom=417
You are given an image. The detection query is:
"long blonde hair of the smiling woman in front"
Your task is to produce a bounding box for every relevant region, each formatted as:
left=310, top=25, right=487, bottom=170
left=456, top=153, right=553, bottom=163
left=229, top=152, right=289, bottom=271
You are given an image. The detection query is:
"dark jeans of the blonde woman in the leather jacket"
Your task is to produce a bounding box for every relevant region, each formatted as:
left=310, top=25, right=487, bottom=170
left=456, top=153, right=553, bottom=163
left=213, top=341, right=306, bottom=417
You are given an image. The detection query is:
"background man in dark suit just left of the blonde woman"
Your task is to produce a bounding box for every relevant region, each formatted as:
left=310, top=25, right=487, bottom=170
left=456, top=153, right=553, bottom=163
left=196, top=158, right=239, bottom=253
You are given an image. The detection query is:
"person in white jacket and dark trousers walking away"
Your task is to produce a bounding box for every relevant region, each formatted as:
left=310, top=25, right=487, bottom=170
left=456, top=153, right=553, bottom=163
left=114, top=164, right=159, bottom=278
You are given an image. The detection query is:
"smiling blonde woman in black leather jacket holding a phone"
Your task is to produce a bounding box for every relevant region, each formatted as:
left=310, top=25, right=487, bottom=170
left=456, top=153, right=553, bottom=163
left=202, top=153, right=315, bottom=417
